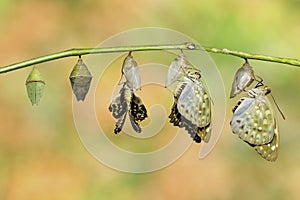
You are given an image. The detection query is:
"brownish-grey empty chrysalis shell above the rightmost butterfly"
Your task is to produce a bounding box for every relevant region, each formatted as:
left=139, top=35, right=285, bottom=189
left=230, top=60, right=255, bottom=98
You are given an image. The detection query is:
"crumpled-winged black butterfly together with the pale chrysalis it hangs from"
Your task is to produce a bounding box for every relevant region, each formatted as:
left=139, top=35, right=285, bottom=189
left=109, top=52, right=147, bottom=134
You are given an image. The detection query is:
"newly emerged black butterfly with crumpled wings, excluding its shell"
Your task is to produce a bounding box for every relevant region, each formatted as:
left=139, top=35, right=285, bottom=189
left=109, top=82, right=148, bottom=134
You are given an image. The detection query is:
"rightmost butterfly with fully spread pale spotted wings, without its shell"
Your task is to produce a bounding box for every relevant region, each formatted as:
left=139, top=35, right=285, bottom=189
left=230, top=86, right=280, bottom=161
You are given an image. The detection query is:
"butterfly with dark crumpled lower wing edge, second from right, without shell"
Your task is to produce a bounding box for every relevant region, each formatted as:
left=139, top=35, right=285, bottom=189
left=169, top=71, right=211, bottom=143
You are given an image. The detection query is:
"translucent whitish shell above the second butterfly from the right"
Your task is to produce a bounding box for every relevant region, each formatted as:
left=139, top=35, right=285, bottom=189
left=166, top=52, right=192, bottom=87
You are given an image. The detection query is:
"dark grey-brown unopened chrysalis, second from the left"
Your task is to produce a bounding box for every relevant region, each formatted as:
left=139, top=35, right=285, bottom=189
left=70, top=58, right=93, bottom=101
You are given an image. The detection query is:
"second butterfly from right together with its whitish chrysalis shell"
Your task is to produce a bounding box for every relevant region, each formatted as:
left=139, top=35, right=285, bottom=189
left=166, top=52, right=211, bottom=143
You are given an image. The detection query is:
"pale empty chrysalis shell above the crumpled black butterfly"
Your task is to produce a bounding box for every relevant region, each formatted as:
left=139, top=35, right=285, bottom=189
left=122, top=51, right=141, bottom=91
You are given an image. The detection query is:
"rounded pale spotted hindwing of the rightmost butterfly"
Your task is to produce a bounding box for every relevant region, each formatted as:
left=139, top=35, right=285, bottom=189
left=230, top=96, right=276, bottom=145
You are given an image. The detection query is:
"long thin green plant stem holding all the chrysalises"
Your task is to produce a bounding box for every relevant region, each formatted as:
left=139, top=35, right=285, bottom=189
left=0, top=43, right=300, bottom=74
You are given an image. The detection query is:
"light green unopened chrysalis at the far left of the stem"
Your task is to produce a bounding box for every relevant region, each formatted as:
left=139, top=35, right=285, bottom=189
left=25, top=67, right=45, bottom=106
